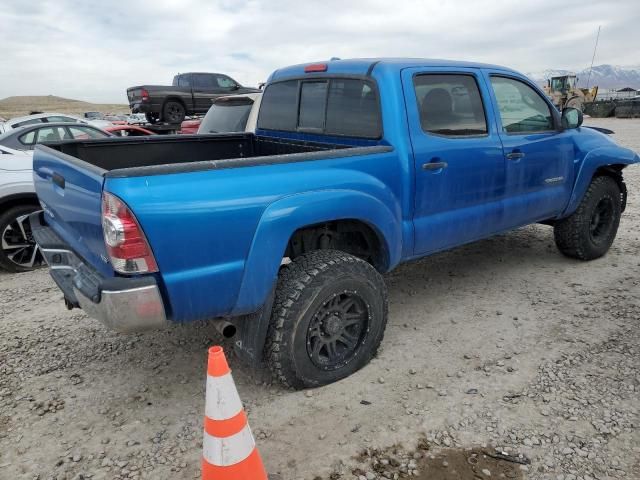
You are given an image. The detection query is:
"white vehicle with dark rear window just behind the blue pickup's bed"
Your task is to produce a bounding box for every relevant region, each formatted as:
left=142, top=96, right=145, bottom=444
left=198, top=92, right=262, bottom=134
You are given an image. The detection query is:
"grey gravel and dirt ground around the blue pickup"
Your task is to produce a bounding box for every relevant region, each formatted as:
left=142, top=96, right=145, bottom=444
left=0, top=119, right=640, bottom=480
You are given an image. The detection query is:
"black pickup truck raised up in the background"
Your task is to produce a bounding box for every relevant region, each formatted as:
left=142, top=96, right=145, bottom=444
left=127, top=73, right=260, bottom=123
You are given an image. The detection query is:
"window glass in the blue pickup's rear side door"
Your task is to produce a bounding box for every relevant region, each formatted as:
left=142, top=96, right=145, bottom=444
left=413, top=74, right=487, bottom=137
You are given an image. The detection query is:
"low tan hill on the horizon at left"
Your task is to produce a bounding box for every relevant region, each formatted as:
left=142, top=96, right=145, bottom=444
left=0, top=95, right=130, bottom=119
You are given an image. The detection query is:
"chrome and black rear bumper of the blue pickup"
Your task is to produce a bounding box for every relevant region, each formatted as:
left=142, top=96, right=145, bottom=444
left=29, top=212, right=167, bottom=332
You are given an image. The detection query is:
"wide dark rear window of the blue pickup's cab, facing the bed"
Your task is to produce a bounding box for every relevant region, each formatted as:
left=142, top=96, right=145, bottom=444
left=258, top=78, right=382, bottom=139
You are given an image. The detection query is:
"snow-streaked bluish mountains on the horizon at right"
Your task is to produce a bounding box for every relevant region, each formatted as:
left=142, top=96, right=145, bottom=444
left=527, top=65, right=640, bottom=90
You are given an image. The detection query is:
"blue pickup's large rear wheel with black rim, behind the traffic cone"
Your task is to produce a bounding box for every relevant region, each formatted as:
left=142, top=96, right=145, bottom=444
left=265, top=250, right=388, bottom=389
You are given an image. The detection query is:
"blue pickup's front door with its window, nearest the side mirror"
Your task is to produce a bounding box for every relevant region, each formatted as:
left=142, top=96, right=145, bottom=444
left=486, top=70, right=576, bottom=226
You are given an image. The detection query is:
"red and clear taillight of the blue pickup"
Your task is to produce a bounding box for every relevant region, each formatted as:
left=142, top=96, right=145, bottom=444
left=102, top=192, right=158, bottom=273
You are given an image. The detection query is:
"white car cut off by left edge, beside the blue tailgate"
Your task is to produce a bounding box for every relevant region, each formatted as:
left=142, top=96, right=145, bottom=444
left=0, top=145, right=44, bottom=272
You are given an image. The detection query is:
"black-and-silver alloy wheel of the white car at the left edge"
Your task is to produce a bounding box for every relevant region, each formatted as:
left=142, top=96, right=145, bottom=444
left=0, top=205, right=44, bottom=273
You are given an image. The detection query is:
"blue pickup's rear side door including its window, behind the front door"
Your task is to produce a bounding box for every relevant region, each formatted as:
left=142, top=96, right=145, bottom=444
left=402, top=67, right=505, bottom=255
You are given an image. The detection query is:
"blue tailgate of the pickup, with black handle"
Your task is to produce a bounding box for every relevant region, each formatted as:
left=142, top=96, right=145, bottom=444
left=33, top=145, right=114, bottom=276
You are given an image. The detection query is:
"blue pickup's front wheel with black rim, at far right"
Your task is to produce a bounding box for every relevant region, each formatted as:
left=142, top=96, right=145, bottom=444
left=554, top=176, right=622, bottom=260
